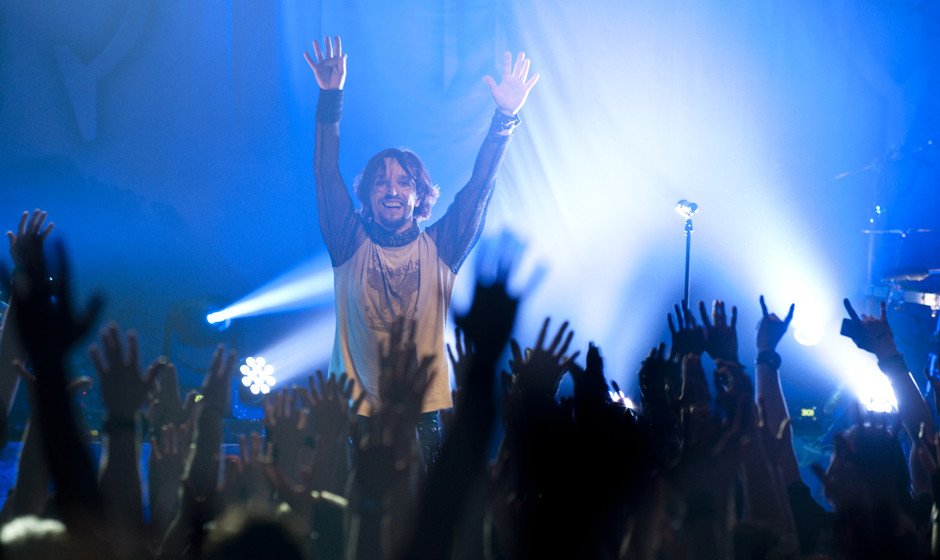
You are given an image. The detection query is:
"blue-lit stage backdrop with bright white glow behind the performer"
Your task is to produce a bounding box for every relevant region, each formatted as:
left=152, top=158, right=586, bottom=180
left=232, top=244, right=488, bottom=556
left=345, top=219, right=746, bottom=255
left=0, top=0, right=940, bottom=416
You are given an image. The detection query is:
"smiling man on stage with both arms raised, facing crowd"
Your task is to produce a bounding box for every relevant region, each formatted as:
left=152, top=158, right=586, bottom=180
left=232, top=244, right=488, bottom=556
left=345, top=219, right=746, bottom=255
left=304, top=36, right=539, bottom=461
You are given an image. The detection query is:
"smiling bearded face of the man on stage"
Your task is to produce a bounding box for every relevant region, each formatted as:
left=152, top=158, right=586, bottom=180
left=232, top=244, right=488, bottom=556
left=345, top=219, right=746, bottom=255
left=369, top=157, right=419, bottom=233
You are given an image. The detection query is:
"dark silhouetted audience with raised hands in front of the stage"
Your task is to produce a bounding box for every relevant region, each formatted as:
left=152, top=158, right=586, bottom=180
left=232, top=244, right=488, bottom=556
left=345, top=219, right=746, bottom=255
left=0, top=210, right=940, bottom=560
